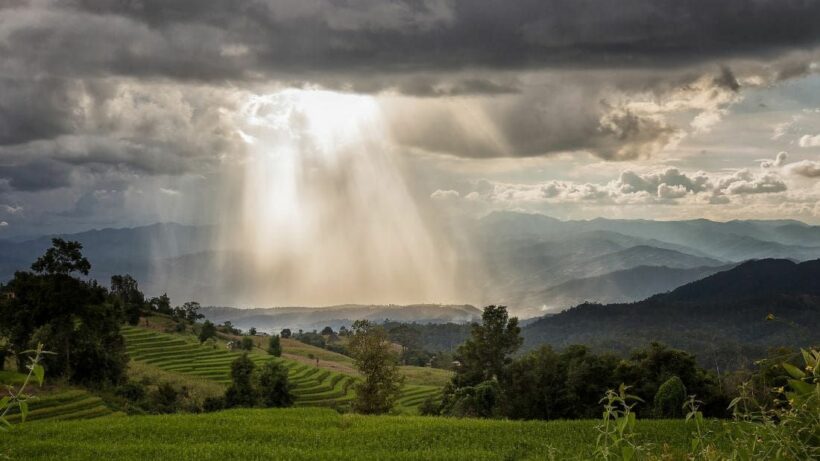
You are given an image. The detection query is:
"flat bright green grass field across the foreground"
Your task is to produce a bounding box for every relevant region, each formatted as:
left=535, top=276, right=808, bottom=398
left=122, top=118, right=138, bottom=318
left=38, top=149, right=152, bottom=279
left=0, top=408, right=716, bottom=461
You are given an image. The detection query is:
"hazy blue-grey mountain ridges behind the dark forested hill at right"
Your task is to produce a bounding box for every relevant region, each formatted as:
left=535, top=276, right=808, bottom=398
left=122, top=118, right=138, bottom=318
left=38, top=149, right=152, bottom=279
left=473, top=212, right=820, bottom=316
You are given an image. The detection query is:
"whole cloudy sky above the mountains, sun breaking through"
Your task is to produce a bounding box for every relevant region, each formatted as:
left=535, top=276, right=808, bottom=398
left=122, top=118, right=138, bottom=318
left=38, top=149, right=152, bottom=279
left=0, top=0, right=820, bottom=238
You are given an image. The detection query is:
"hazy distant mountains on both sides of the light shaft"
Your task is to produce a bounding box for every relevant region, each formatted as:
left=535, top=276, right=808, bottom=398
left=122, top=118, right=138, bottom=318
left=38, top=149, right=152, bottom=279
left=0, top=212, right=820, bottom=317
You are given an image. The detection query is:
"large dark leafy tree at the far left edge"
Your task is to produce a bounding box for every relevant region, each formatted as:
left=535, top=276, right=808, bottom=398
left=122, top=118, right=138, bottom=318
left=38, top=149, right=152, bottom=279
left=0, top=239, right=128, bottom=385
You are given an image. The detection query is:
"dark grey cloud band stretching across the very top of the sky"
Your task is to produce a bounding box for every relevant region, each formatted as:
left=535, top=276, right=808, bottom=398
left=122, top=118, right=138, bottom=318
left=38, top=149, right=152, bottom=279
left=2, top=0, right=820, bottom=80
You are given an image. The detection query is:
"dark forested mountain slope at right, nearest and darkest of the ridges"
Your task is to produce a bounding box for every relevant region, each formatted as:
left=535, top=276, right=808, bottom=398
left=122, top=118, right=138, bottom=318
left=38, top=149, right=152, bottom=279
left=523, top=259, right=820, bottom=366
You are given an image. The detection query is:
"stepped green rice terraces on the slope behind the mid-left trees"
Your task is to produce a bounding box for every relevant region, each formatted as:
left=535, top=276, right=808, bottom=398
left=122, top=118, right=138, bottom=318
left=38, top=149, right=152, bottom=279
left=122, top=327, right=440, bottom=413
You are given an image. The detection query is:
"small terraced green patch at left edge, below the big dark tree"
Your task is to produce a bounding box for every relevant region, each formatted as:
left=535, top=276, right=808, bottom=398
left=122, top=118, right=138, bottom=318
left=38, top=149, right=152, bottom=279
left=7, top=390, right=114, bottom=424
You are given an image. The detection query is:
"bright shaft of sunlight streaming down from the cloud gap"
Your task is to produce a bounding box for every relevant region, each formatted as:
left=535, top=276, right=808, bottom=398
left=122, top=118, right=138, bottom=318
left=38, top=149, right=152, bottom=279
left=215, top=90, right=453, bottom=305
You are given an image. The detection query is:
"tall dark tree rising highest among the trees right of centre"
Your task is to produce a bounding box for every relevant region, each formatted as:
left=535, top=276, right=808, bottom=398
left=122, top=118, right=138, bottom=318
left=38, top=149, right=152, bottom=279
left=453, top=306, right=523, bottom=387
